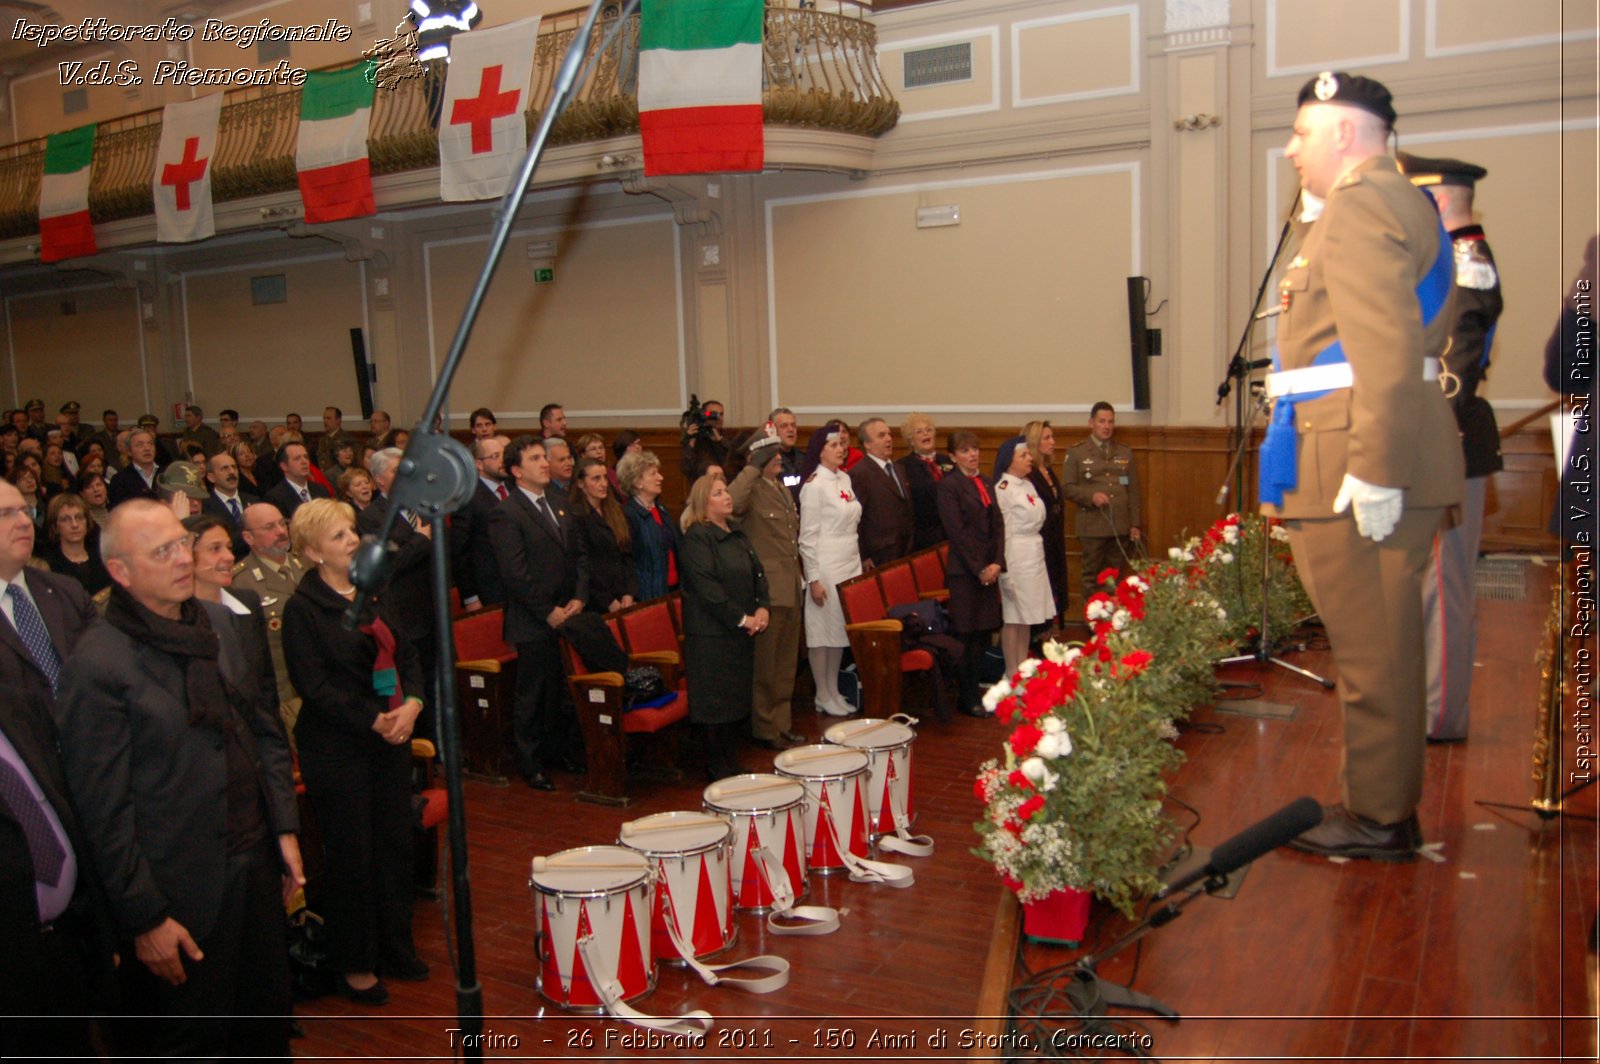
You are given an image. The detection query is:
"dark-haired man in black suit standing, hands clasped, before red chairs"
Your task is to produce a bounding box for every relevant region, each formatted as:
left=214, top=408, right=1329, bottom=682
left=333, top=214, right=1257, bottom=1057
left=490, top=435, right=589, bottom=790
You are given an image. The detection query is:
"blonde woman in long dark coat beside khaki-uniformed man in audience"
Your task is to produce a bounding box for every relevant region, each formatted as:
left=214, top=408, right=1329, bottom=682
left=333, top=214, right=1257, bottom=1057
left=682, top=477, right=768, bottom=779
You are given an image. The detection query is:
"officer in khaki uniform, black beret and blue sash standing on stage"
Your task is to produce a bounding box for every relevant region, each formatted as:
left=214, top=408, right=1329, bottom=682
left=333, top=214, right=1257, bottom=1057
left=1261, top=72, right=1462, bottom=861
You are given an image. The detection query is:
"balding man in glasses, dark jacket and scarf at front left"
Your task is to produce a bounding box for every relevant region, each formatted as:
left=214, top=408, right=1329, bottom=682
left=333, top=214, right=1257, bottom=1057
left=58, top=499, right=304, bottom=1058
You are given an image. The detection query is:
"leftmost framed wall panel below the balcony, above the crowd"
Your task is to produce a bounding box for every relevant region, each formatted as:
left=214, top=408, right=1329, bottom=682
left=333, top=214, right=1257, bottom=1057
left=5, top=285, right=147, bottom=424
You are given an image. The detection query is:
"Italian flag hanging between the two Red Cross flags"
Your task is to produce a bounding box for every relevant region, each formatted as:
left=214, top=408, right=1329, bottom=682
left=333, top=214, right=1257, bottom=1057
left=294, top=61, right=378, bottom=222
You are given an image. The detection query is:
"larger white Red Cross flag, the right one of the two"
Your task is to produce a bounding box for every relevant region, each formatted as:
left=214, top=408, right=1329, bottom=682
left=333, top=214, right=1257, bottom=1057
left=438, top=16, right=539, bottom=200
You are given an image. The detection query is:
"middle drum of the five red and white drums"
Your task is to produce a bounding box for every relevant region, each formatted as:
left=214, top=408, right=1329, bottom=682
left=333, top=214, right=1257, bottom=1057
left=704, top=773, right=810, bottom=912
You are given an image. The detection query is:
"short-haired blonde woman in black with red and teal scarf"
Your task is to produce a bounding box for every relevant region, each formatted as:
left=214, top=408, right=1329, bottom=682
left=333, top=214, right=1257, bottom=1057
left=283, top=499, right=427, bottom=1005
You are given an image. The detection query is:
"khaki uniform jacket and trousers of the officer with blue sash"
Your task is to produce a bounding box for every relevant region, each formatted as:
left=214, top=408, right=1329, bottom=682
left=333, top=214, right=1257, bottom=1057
left=1262, top=157, right=1462, bottom=824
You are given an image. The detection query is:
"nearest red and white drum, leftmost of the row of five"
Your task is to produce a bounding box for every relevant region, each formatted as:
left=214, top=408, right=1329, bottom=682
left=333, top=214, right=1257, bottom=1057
left=528, top=846, right=656, bottom=1013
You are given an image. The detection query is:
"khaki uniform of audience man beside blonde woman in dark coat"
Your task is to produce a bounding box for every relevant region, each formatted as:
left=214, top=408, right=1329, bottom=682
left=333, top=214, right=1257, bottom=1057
left=728, top=462, right=803, bottom=739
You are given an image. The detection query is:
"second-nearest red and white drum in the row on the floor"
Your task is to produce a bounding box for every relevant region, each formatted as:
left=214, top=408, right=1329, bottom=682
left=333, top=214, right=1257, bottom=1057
left=618, top=813, right=738, bottom=965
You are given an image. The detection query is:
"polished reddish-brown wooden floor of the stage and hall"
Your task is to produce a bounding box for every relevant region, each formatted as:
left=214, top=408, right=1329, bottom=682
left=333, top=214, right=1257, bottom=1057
left=294, top=566, right=1600, bottom=1061
